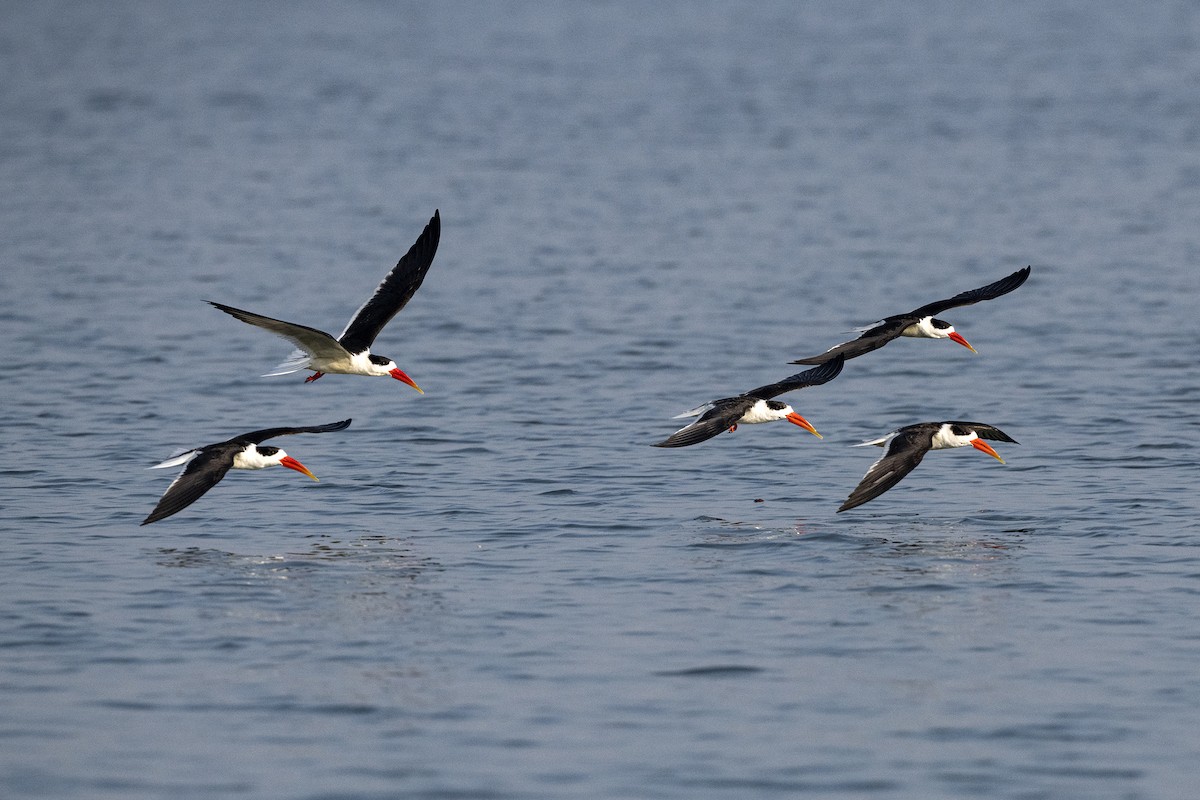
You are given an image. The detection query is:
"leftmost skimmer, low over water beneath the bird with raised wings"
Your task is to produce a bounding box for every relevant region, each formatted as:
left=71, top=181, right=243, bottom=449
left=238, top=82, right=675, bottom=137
left=142, top=420, right=350, bottom=525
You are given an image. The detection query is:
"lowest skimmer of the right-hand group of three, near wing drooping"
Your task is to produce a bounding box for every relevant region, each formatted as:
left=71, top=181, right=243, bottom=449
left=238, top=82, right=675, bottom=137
left=838, top=421, right=1018, bottom=511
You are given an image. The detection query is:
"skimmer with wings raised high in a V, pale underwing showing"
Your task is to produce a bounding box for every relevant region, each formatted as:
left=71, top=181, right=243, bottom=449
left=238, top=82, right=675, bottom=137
left=210, top=211, right=442, bottom=395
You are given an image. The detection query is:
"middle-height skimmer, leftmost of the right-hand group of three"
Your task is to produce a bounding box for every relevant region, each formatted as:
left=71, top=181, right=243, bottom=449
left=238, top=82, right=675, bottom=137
left=654, top=357, right=844, bottom=447
